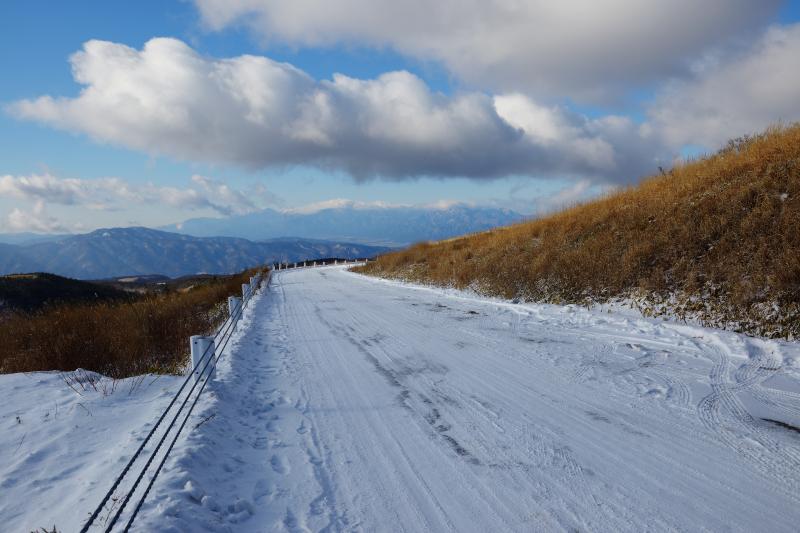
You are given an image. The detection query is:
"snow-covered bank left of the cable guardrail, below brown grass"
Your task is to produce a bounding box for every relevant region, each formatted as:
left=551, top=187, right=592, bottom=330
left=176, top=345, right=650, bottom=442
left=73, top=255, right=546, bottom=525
left=0, top=371, right=180, bottom=532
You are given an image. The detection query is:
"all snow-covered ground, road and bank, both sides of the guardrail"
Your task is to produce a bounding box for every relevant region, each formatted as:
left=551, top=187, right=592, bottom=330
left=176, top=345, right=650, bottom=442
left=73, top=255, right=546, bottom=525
left=0, top=267, right=800, bottom=532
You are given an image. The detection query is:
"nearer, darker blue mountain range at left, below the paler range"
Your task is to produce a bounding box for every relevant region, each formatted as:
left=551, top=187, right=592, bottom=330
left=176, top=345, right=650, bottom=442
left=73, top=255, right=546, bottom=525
left=0, top=228, right=387, bottom=279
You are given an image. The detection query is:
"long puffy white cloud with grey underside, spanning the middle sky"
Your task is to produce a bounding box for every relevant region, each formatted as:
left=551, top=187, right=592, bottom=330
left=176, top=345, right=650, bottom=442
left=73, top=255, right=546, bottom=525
left=11, top=38, right=658, bottom=181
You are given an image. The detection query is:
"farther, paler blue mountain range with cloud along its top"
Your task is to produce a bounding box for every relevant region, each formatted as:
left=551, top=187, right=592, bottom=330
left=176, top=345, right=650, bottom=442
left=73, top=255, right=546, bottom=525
left=160, top=204, right=524, bottom=247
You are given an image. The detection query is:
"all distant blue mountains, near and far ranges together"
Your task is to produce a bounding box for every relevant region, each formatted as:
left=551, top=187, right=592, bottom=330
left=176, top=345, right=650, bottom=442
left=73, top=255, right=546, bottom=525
left=0, top=202, right=523, bottom=279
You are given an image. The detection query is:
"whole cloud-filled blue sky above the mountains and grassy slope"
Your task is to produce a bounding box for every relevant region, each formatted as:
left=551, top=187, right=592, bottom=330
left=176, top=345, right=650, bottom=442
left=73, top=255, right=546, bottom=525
left=0, top=0, right=800, bottom=233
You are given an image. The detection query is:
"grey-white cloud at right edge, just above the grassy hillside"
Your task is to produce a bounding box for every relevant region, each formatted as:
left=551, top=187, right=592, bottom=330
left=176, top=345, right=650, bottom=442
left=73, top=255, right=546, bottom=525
left=648, top=24, right=800, bottom=149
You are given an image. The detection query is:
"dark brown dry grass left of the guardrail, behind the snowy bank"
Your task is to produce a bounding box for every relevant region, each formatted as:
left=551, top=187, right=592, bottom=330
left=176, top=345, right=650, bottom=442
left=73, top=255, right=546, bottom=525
left=0, top=270, right=262, bottom=378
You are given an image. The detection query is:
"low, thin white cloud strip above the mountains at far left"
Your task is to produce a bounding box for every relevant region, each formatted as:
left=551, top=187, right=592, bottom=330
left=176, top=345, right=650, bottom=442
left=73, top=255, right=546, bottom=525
left=0, top=174, right=258, bottom=220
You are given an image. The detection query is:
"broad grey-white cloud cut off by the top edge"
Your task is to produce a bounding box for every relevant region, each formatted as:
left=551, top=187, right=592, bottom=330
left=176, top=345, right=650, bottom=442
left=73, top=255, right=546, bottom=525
left=195, top=0, right=781, bottom=101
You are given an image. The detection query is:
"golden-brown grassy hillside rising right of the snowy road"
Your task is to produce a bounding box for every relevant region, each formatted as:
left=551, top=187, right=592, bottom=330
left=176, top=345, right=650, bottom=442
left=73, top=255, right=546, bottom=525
left=361, top=124, right=800, bottom=338
